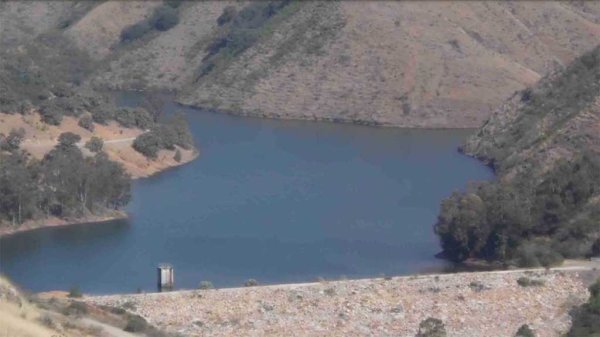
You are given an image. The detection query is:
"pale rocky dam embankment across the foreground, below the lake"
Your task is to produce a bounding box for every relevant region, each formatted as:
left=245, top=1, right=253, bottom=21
left=87, top=268, right=592, bottom=337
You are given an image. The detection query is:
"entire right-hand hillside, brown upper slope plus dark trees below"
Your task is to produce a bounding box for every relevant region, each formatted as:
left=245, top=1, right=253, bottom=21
left=436, top=46, right=600, bottom=265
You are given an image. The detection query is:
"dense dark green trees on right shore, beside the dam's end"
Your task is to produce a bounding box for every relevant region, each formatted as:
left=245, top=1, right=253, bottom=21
left=435, top=153, right=600, bottom=266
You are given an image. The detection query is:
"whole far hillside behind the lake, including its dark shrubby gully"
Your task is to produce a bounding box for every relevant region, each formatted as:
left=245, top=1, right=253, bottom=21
left=0, top=1, right=600, bottom=127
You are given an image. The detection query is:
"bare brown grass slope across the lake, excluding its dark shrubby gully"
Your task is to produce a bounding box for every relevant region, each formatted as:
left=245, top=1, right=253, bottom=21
left=100, top=1, right=600, bottom=127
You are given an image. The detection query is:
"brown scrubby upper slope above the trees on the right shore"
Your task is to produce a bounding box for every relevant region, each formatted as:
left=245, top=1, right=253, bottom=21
left=463, top=45, right=600, bottom=179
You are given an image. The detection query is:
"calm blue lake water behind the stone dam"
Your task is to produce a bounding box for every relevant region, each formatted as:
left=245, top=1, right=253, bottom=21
left=0, top=96, right=493, bottom=294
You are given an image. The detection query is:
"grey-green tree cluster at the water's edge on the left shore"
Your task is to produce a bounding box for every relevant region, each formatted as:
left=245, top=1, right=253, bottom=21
left=0, top=133, right=131, bottom=226
